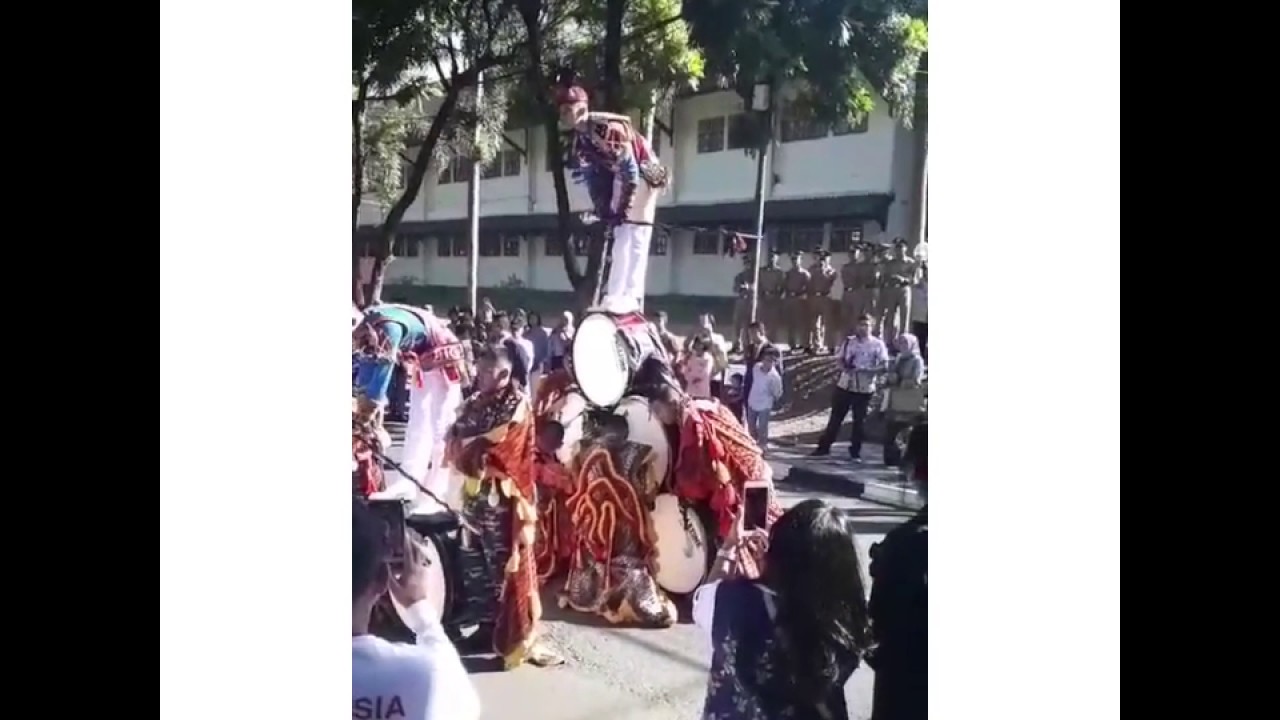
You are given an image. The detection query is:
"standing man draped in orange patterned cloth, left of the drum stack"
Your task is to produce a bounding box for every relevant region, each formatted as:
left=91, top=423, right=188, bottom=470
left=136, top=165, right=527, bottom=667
left=445, top=347, right=559, bottom=669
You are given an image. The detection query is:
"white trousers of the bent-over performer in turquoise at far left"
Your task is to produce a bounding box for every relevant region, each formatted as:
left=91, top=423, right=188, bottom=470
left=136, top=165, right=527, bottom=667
left=399, top=370, right=462, bottom=501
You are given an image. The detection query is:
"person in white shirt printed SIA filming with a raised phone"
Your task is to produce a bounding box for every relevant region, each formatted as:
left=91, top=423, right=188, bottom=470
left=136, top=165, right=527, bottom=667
left=351, top=501, right=480, bottom=720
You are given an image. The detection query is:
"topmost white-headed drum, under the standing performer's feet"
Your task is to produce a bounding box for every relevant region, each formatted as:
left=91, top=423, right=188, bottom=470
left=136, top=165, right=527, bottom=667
left=570, top=311, right=668, bottom=407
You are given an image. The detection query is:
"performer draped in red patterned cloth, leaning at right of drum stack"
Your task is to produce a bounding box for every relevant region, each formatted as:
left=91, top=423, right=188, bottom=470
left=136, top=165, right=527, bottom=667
left=649, top=386, right=782, bottom=578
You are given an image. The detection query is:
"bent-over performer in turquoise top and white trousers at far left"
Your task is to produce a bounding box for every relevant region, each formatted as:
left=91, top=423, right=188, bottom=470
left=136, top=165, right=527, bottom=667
left=352, top=305, right=467, bottom=498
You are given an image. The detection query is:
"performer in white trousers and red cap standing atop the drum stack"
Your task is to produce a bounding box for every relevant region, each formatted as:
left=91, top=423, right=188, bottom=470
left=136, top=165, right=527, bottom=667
left=557, top=78, right=669, bottom=314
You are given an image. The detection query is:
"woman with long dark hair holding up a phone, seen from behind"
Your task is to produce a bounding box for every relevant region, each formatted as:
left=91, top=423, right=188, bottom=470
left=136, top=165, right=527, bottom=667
left=694, top=500, right=870, bottom=720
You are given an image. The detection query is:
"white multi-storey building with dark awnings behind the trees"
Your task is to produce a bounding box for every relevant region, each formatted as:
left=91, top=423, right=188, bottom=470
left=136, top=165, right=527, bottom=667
left=362, top=85, right=919, bottom=297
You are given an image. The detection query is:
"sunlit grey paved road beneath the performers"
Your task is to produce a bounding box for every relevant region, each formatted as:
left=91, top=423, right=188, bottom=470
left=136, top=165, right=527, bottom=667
left=378, top=425, right=908, bottom=720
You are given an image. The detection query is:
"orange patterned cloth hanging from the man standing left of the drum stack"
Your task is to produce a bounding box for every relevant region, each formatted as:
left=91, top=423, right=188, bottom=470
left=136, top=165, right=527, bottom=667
left=445, top=387, right=541, bottom=667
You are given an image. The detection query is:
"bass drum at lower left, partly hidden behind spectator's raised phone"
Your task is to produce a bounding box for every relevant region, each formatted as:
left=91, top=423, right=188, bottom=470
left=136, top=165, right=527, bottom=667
left=369, top=512, right=462, bottom=643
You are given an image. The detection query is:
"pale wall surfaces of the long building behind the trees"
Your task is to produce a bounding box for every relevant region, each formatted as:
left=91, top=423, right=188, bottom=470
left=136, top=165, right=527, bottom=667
left=362, top=85, right=914, bottom=296
